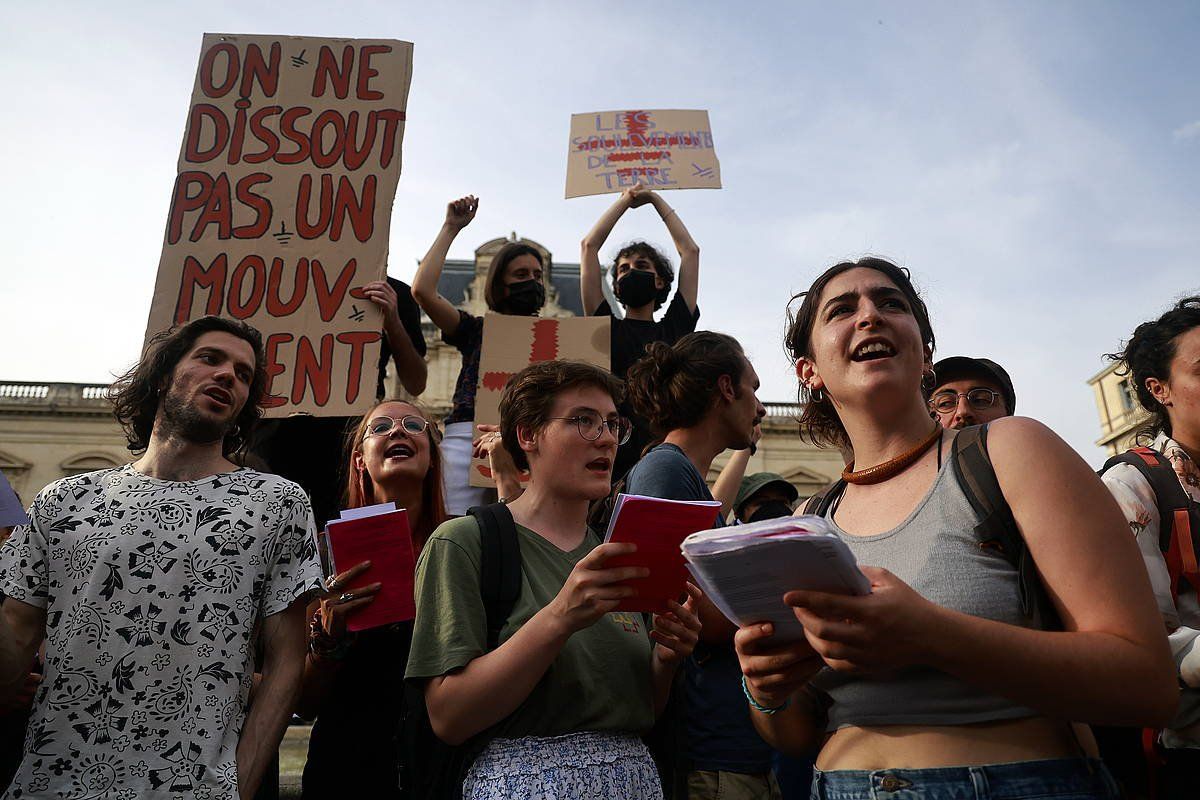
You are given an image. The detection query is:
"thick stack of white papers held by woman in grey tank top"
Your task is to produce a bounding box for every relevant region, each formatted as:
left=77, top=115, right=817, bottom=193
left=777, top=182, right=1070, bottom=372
left=680, top=516, right=871, bottom=640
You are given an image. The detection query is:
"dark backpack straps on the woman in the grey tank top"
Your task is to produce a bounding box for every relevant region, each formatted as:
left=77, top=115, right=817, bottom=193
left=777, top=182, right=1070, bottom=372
left=804, top=423, right=1062, bottom=631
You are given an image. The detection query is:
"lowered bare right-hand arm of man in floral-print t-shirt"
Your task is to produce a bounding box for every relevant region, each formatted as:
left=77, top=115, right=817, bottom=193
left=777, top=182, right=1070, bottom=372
left=238, top=600, right=307, bottom=798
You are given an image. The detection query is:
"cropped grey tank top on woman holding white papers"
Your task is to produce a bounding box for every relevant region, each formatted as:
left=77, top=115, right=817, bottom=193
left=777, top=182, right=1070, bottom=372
left=812, top=443, right=1038, bottom=730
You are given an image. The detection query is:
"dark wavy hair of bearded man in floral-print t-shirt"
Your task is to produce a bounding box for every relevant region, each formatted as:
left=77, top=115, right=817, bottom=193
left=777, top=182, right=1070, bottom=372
left=108, top=315, right=266, bottom=456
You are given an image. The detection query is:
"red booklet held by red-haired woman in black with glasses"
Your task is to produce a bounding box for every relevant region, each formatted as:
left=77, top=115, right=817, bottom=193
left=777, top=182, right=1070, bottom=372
left=325, top=503, right=416, bottom=631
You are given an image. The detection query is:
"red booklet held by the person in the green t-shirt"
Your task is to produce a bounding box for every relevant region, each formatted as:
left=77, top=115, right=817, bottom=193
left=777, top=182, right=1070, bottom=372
left=604, top=494, right=721, bottom=612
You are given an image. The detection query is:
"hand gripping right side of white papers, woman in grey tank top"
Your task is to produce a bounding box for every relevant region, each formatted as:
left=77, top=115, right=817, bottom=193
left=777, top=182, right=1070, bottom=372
left=784, top=566, right=940, bottom=673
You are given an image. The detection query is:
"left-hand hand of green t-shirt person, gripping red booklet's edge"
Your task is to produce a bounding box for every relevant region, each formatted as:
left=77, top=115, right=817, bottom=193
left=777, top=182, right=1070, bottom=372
left=546, top=542, right=650, bottom=634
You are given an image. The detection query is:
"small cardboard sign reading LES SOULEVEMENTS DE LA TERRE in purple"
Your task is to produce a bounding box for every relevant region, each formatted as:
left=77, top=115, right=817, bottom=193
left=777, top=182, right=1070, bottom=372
left=566, top=109, right=721, bottom=197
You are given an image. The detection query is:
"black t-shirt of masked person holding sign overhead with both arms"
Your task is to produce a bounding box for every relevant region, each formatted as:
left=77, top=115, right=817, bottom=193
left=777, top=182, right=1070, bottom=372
left=593, top=291, right=700, bottom=483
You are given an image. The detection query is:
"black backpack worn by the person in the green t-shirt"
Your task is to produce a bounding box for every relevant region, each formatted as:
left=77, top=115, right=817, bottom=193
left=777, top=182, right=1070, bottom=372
left=400, top=503, right=521, bottom=800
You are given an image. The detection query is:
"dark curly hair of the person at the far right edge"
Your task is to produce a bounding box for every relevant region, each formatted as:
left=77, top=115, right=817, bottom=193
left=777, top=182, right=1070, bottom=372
left=1104, top=295, right=1200, bottom=440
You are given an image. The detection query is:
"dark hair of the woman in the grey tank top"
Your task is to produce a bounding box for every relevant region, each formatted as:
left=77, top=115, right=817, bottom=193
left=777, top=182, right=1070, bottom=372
left=784, top=257, right=936, bottom=447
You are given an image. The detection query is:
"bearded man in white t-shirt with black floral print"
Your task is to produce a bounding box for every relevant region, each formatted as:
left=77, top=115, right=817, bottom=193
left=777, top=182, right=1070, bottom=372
left=0, top=317, right=320, bottom=800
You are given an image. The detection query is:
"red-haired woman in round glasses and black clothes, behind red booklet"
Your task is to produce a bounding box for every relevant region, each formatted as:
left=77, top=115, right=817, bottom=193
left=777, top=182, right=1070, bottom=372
left=296, top=401, right=446, bottom=798
